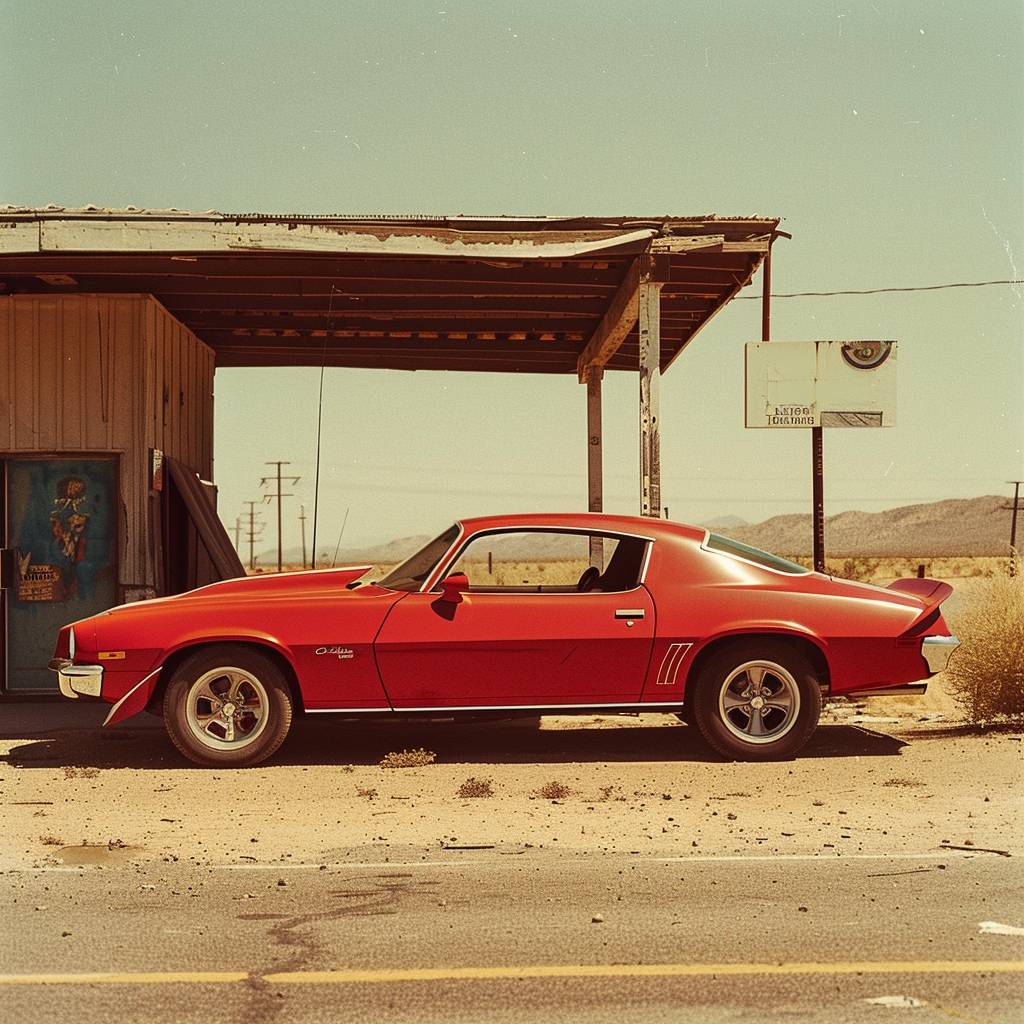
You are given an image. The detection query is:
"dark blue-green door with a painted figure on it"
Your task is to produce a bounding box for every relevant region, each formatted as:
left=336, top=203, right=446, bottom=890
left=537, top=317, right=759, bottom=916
left=3, top=457, right=118, bottom=693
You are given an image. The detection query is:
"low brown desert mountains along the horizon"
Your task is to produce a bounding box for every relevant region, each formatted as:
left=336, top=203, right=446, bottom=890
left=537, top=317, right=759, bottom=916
left=253, top=495, right=1007, bottom=568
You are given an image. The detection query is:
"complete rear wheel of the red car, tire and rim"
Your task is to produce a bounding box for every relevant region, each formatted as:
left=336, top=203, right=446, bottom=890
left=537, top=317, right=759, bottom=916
left=691, top=637, right=821, bottom=761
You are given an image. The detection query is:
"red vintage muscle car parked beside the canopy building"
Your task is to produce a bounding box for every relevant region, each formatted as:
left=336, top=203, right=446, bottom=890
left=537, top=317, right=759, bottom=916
left=51, top=514, right=956, bottom=765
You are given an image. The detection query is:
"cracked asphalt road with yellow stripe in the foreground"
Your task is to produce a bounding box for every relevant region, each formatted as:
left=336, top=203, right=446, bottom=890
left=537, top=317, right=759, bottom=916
left=0, top=843, right=1024, bottom=1024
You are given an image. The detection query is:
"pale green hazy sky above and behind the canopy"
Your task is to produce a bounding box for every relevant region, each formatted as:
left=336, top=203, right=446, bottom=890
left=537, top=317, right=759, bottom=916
left=0, top=0, right=1024, bottom=548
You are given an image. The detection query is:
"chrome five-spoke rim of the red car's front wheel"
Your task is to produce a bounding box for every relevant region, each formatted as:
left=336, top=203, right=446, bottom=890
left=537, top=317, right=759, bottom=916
left=185, top=668, right=270, bottom=751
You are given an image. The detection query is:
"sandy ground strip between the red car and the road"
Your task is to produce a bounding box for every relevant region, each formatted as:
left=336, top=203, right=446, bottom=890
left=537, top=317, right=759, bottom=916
left=0, top=692, right=1024, bottom=869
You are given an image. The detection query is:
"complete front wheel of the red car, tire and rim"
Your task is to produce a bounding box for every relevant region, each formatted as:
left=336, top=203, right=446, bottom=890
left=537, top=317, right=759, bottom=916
left=164, top=644, right=292, bottom=768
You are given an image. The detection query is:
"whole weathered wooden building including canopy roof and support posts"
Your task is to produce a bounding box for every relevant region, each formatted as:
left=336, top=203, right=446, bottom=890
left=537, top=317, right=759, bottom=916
left=0, top=207, right=784, bottom=691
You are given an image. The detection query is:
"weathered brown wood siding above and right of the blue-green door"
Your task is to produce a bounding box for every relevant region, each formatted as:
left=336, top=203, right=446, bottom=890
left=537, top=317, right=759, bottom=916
left=0, top=295, right=214, bottom=590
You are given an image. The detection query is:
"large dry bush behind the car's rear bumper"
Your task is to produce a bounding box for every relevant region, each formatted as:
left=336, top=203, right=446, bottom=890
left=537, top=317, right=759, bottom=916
left=945, top=577, right=1024, bottom=723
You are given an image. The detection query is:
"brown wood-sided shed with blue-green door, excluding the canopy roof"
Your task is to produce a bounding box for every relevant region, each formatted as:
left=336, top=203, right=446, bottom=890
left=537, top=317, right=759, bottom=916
left=0, top=294, right=235, bottom=692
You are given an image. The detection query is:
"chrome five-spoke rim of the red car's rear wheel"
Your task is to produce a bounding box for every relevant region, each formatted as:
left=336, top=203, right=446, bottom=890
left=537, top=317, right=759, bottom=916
left=718, top=660, right=800, bottom=744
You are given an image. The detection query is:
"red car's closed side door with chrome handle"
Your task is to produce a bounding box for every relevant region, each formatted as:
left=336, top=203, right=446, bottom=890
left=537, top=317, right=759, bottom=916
left=375, top=536, right=654, bottom=710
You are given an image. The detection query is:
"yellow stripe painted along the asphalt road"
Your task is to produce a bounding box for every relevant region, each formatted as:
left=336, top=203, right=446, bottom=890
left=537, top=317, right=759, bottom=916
left=0, top=961, right=1024, bottom=985
